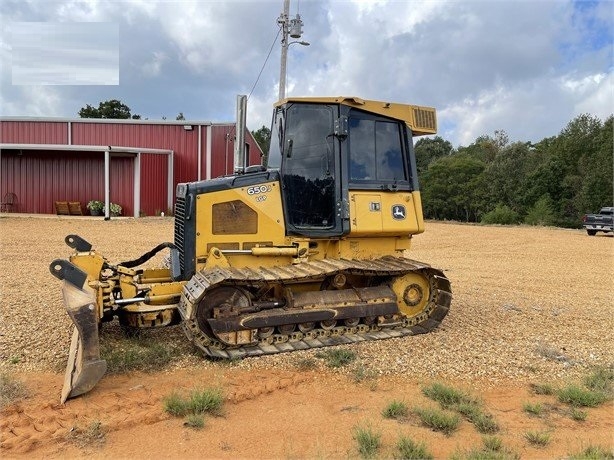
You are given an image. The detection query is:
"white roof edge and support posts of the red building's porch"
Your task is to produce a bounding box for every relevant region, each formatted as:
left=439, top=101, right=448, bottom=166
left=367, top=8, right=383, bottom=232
left=0, top=144, right=174, bottom=219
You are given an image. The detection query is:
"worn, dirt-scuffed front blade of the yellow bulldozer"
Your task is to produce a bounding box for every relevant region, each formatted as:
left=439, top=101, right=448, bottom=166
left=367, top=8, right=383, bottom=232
left=61, top=280, right=107, bottom=404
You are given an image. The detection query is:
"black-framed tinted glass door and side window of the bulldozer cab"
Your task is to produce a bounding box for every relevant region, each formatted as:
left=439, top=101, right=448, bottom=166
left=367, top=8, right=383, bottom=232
left=264, top=99, right=424, bottom=237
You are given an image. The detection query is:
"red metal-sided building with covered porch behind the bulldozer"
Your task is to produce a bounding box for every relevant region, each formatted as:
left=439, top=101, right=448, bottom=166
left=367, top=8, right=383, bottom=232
left=0, top=117, right=262, bottom=217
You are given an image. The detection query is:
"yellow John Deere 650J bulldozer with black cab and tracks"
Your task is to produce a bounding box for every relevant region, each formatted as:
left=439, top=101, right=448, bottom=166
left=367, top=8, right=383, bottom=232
left=50, top=97, right=452, bottom=402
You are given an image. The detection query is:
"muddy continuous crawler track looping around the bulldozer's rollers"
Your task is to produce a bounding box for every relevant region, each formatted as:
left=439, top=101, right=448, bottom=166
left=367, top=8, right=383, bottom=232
left=179, top=256, right=452, bottom=359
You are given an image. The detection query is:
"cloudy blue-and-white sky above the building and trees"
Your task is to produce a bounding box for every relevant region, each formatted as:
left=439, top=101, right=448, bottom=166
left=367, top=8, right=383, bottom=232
left=0, top=0, right=614, bottom=147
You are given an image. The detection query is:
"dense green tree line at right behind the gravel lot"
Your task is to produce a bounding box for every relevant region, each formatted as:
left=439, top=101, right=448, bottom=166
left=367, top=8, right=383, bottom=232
left=415, top=114, right=614, bottom=228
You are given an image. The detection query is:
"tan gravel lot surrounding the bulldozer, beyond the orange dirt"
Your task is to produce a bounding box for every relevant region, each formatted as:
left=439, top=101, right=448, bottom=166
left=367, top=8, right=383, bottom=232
left=0, top=215, right=614, bottom=385
